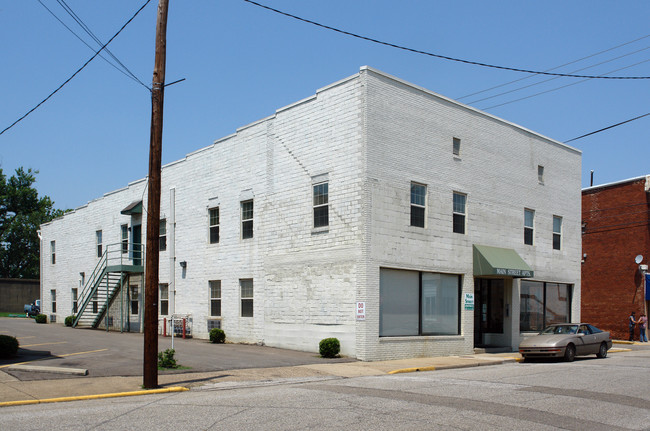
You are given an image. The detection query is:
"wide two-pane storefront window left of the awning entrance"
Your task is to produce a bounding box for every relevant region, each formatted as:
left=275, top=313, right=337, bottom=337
left=379, top=268, right=461, bottom=337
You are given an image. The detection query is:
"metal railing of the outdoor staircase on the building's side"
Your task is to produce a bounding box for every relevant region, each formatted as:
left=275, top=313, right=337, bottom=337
left=72, top=242, right=144, bottom=326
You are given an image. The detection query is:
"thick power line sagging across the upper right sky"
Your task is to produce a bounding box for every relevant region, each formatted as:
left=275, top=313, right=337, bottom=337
left=243, top=0, right=650, bottom=79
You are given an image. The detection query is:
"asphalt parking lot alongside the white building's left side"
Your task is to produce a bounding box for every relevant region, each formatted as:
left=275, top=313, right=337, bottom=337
left=0, top=317, right=355, bottom=381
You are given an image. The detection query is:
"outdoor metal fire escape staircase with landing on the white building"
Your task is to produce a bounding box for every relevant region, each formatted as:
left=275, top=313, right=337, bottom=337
left=72, top=243, right=144, bottom=328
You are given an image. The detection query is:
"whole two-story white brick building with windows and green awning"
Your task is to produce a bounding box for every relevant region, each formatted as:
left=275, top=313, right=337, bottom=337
left=41, top=67, right=581, bottom=360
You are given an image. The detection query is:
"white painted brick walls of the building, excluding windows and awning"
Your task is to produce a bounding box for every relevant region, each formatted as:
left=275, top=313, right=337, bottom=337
left=42, top=68, right=580, bottom=360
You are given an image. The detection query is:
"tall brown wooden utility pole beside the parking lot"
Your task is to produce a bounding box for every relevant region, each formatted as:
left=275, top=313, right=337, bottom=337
left=142, top=0, right=169, bottom=389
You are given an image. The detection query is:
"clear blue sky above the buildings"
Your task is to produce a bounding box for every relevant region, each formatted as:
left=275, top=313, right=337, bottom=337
left=0, top=0, right=650, bottom=209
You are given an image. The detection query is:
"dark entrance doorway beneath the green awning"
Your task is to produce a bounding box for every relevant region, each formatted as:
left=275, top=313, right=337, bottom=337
left=474, top=278, right=505, bottom=347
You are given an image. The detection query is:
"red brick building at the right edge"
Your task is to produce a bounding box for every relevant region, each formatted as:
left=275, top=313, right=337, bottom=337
left=581, top=175, right=650, bottom=341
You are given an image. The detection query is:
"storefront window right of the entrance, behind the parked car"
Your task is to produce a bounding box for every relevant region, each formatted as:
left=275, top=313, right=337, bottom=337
left=519, top=280, right=572, bottom=331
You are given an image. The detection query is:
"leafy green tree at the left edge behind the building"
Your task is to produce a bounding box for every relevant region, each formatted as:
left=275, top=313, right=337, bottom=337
left=0, top=168, right=64, bottom=278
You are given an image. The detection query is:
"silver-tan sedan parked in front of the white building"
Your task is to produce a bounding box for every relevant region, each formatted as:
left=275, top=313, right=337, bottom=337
left=519, top=323, right=612, bottom=362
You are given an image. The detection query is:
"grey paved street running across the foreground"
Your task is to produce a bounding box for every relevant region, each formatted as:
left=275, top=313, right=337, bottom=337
left=2, top=347, right=650, bottom=430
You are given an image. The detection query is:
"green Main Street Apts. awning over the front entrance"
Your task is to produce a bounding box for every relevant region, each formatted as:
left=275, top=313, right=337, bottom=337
left=474, top=245, right=535, bottom=278
